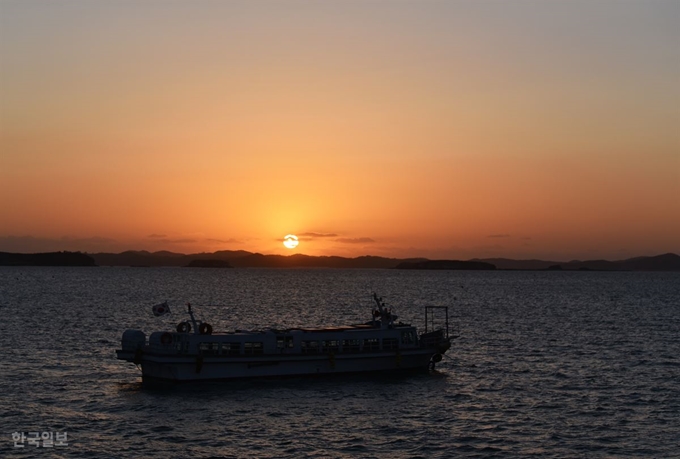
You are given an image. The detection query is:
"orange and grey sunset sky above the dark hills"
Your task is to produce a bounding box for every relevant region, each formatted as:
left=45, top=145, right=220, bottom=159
left=0, top=0, right=680, bottom=260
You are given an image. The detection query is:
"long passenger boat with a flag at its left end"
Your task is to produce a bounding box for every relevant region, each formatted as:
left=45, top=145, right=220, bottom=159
left=116, top=293, right=454, bottom=383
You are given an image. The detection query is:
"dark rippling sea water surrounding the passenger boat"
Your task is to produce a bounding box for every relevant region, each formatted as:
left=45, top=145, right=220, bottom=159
left=0, top=267, right=680, bottom=458
